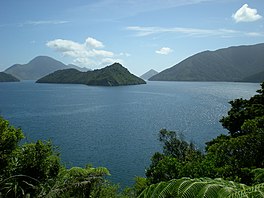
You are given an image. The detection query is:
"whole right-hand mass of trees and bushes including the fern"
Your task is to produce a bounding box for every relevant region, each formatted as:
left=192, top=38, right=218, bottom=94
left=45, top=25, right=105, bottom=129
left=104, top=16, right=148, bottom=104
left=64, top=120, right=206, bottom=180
left=137, top=83, right=264, bottom=197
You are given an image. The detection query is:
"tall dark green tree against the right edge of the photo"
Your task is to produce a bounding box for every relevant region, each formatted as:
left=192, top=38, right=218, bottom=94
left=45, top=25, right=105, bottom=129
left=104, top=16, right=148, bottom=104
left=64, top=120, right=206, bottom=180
left=205, top=83, right=264, bottom=184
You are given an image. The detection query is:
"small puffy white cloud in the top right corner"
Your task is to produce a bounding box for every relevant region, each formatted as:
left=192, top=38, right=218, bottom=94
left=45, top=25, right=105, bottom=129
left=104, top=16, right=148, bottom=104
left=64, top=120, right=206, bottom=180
left=232, top=4, right=262, bottom=23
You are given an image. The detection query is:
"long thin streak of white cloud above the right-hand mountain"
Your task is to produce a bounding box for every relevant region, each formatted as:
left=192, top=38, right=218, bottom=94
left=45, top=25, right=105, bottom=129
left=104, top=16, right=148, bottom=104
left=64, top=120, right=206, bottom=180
left=126, top=26, right=264, bottom=37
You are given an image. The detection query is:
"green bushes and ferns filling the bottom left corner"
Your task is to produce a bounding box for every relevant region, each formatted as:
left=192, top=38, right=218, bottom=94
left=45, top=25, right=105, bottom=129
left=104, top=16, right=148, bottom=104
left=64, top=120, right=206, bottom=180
left=0, top=118, right=113, bottom=197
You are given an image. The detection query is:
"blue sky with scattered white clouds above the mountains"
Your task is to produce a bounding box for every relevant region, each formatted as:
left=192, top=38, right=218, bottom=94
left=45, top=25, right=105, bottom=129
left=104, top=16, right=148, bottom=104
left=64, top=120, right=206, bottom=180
left=0, top=0, right=264, bottom=76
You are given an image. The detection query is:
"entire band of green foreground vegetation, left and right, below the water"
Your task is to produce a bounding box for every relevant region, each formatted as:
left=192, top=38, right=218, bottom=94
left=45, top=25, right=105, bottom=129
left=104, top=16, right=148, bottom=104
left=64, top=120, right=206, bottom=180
left=0, top=83, right=264, bottom=198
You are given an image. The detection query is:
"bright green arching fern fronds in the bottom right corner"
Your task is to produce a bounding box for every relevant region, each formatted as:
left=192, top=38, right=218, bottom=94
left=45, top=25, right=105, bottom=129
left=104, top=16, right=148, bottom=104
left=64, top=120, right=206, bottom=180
left=139, top=178, right=264, bottom=198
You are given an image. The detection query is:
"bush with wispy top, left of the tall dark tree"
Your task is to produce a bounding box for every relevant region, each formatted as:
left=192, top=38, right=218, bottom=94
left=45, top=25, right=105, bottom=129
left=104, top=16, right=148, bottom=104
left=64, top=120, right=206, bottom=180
left=146, top=129, right=203, bottom=183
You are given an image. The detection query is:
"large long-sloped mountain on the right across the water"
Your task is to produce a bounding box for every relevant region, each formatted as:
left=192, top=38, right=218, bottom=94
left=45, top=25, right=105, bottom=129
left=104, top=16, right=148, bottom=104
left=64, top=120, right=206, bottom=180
left=149, top=43, right=264, bottom=82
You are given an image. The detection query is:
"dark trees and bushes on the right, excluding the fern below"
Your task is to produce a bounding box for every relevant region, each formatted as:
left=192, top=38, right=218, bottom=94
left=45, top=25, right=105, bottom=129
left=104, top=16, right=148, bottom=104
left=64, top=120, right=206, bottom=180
left=146, top=83, right=264, bottom=185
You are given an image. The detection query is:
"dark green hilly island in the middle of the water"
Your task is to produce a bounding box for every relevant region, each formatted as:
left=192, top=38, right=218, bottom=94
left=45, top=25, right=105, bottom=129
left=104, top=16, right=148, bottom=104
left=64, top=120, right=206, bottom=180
left=37, top=63, right=146, bottom=86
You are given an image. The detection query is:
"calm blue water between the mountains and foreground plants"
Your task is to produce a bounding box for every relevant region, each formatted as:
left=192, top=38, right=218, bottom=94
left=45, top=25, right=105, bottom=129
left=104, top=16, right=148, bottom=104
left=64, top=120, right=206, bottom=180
left=0, top=81, right=260, bottom=186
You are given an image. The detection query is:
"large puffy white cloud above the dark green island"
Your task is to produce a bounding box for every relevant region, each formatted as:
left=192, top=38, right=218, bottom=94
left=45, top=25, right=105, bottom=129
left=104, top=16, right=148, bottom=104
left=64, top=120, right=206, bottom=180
left=46, top=37, right=122, bottom=68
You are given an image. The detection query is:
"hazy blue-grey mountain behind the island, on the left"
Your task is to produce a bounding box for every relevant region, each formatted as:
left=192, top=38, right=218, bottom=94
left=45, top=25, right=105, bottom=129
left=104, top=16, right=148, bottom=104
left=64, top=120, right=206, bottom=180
left=5, top=56, right=88, bottom=80
